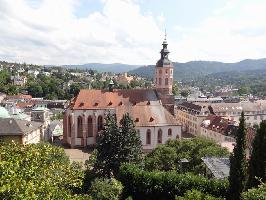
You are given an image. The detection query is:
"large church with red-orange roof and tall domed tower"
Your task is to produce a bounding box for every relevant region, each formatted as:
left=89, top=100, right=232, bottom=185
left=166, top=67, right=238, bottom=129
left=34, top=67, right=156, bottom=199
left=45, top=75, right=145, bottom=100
left=63, top=39, right=181, bottom=151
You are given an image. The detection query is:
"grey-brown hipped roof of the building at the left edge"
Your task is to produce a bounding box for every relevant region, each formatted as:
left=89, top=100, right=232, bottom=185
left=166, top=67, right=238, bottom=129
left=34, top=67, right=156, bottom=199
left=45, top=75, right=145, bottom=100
left=0, top=118, right=42, bottom=135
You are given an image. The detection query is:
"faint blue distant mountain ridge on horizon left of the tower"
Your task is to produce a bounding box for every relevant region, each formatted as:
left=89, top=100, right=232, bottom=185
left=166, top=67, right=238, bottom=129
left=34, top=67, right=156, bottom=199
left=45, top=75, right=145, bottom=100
left=63, top=63, right=141, bottom=73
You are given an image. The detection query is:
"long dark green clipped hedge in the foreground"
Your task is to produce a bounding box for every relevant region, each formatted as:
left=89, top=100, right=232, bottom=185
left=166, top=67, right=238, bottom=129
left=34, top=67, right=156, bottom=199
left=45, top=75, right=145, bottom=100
left=118, top=164, right=228, bottom=200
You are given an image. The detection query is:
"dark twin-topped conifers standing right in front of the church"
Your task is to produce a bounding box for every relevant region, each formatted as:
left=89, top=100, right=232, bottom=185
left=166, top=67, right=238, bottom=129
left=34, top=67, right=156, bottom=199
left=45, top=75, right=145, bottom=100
left=94, top=113, right=142, bottom=178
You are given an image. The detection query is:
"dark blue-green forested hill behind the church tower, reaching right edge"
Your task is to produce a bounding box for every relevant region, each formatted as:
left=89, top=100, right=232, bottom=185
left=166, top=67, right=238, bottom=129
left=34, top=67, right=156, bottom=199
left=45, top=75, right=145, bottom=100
left=129, top=58, right=266, bottom=80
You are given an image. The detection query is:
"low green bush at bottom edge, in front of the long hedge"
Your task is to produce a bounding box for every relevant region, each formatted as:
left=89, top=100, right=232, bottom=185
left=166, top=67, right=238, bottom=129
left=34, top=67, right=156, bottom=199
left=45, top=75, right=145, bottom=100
left=175, top=190, right=222, bottom=200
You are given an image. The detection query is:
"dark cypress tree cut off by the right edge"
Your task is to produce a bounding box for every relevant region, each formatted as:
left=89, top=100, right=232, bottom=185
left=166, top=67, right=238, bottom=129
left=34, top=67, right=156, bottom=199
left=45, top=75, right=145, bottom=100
left=247, top=121, right=266, bottom=188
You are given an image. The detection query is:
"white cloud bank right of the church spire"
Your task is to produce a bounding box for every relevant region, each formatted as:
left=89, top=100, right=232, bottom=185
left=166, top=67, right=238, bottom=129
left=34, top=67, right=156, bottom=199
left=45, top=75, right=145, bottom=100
left=172, top=1, right=266, bottom=62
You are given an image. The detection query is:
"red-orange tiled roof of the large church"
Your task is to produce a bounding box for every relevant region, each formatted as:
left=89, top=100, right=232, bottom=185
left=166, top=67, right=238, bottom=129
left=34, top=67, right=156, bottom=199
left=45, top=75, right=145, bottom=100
left=70, top=89, right=180, bottom=126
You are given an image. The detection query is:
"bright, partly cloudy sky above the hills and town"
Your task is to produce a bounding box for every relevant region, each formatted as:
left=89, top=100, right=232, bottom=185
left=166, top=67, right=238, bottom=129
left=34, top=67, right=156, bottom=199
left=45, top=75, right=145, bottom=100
left=0, top=0, right=266, bottom=65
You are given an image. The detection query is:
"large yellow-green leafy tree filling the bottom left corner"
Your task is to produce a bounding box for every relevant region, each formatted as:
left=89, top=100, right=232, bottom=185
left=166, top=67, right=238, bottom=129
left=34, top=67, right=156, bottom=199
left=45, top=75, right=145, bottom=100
left=0, top=143, right=83, bottom=199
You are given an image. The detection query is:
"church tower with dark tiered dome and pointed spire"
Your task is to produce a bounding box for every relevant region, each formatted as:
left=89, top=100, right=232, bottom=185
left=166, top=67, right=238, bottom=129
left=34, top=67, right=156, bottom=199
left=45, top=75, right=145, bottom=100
left=154, top=34, right=173, bottom=95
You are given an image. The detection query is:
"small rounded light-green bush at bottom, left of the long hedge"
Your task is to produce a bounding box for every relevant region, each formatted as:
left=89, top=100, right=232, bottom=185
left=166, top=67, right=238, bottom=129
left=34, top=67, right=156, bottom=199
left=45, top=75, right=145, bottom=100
left=89, top=178, right=123, bottom=200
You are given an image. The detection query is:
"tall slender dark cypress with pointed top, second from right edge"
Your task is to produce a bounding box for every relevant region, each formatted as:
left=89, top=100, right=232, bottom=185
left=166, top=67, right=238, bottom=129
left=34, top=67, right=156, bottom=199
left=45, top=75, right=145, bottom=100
left=227, top=112, right=247, bottom=200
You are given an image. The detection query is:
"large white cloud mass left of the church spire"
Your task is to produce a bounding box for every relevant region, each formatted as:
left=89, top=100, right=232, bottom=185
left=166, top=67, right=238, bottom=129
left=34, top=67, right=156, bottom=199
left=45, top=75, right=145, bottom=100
left=0, top=0, right=163, bottom=64
